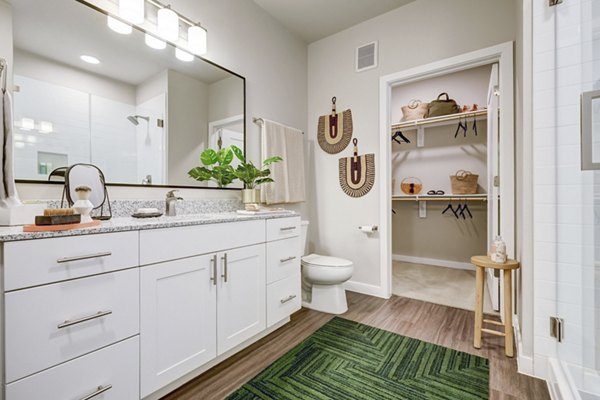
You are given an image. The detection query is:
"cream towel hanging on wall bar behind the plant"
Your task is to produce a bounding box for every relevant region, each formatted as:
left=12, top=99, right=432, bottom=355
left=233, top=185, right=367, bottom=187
left=261, top=119, right=306, bottom=204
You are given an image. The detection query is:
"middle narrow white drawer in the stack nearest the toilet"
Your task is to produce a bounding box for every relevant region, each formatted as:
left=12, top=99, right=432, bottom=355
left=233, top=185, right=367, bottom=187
left=267, top=236, right=301, bottom=283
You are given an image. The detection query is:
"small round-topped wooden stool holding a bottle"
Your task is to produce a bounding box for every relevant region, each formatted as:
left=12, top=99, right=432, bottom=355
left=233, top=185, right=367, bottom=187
left=471, top=256, right=519, bottom=357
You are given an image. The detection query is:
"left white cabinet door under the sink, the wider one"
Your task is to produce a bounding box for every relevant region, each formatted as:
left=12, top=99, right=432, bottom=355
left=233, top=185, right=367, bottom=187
left=140, top=255, right=217, bottom=397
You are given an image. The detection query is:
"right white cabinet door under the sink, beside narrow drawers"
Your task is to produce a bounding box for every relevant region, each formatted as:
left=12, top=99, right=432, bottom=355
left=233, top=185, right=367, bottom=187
left=217, top=244, right=266, bottom=355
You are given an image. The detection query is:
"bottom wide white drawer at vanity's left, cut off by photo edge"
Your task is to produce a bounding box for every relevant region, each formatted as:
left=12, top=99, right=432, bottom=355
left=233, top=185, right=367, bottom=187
left=6, top=336, right=140, bottom=400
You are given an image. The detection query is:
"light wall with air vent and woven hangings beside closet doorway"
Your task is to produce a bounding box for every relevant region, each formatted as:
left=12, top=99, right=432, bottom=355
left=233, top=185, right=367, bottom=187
left=308, top=0, right=517, bottom=291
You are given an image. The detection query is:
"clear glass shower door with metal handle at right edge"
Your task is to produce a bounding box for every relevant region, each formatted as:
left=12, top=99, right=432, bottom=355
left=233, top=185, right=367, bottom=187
left=552, top=0, right=600, bottom=400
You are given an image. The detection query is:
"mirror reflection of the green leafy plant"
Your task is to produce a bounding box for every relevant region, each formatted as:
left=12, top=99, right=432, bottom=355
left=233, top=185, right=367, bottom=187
left=188, top=148, right=236, bottom=188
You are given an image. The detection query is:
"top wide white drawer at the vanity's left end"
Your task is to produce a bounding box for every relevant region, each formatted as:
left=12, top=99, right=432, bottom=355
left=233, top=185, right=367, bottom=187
left=4, top=232, right=138, bottom=291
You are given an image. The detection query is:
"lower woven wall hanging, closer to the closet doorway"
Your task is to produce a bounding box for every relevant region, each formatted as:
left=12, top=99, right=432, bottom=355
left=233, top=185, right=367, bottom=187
left=339, top=139, right=375, bottom=197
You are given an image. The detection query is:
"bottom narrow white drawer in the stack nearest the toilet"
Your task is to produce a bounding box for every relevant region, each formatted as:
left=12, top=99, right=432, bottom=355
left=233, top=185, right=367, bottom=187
left=267, top=273, right=302, bottom=328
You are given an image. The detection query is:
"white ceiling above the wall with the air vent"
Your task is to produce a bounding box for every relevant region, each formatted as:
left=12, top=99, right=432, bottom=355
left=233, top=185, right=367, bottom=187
left=254, top=0, right=415, bottom=43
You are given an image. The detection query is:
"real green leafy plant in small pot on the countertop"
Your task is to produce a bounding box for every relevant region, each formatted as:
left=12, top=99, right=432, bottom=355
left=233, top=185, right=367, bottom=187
left=231, top=146, right=283, bottom=204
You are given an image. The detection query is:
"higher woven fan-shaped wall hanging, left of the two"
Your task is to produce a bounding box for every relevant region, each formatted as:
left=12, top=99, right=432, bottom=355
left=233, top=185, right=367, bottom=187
left=317, top=97, right=352, bottom=154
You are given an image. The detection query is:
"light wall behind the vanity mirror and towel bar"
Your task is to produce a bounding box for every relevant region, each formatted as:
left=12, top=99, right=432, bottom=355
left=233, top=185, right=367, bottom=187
left=7, top=0, right=307, bottom=206
